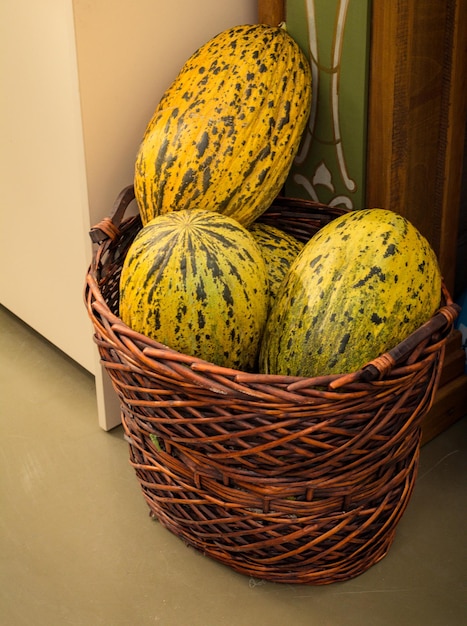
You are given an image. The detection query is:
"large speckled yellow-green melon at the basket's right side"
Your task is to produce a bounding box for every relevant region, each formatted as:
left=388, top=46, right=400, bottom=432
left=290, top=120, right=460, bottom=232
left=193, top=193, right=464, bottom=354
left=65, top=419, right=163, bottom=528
left=260, top=209, right=441, bottom=376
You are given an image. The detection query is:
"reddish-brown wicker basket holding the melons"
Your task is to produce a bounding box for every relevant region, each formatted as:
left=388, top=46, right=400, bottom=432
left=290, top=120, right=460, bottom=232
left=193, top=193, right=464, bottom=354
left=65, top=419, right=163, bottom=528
left=85, top=187, right=458, bottom=585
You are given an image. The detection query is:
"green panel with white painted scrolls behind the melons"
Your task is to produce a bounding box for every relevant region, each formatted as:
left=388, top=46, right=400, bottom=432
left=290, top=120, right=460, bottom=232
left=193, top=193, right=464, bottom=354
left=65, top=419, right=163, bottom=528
left=285, top=0, right=371, bottom=208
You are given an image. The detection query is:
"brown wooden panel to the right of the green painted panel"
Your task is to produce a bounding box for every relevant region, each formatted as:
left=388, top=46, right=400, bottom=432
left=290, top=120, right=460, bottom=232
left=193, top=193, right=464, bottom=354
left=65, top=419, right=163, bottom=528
left=366, top=0, right=467, bottom=292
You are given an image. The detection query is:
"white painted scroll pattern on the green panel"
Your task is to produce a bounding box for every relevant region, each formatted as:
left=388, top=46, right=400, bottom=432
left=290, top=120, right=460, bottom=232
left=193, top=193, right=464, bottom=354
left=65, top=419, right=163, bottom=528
left=293, top=0, right=356, bottom=209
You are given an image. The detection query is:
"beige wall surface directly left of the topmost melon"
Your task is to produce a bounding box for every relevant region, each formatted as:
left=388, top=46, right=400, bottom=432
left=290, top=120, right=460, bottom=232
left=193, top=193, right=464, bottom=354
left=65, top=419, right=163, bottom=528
left=73, top=0, right=257, bottom=222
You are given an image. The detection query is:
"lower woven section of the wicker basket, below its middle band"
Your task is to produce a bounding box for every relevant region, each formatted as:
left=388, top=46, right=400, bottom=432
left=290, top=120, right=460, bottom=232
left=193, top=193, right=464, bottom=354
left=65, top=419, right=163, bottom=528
left=125, top=424, right=419, bottom=585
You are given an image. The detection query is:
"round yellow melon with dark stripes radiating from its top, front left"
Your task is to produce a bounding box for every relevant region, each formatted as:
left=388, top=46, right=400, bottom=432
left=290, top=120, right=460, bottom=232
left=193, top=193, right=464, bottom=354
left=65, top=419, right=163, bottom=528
left=120, top=209, right=268, bottom=370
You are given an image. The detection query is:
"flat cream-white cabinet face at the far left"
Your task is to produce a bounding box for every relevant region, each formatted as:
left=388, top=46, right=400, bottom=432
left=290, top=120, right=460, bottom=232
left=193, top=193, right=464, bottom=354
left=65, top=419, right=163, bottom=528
left=0, top=0, right=94, bottom=369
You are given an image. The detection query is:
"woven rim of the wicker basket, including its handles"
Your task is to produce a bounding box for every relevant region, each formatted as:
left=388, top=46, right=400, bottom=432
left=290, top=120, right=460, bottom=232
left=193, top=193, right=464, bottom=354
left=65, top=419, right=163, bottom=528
left=84, top=185, right=460, bottom=392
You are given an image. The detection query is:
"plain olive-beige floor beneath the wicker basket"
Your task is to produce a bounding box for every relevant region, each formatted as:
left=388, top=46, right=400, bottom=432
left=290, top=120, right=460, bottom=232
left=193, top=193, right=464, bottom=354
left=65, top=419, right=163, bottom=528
left=0, top=308, right=467, bottom=626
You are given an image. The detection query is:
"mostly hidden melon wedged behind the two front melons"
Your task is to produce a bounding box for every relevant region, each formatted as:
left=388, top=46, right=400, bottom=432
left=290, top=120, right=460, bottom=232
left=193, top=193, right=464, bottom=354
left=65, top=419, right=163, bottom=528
left=248, top=222, right=304, bottom=306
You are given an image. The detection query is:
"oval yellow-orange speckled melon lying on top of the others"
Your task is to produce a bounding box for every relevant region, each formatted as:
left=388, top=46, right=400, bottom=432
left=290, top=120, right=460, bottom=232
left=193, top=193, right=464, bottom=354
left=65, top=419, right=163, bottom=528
left=134, top=24, right=311, bottom=226
